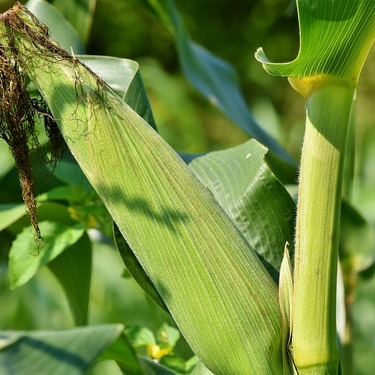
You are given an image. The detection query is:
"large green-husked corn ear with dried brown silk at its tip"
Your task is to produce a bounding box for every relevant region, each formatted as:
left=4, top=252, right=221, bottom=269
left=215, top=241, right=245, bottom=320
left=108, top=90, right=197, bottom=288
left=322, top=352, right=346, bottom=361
left=0, top=5, right=282, bottom=374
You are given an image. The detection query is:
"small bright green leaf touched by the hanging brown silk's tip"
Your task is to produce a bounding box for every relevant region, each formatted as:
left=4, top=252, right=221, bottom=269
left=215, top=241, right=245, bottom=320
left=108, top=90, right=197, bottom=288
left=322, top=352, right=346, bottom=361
left=9, top=221, right=84, bottom=288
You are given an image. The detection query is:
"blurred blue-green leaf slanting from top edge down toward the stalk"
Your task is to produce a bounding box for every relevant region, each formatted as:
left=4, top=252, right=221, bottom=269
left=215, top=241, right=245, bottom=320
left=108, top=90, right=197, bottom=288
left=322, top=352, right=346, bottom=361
left=149, top=0, right=294, bottom=165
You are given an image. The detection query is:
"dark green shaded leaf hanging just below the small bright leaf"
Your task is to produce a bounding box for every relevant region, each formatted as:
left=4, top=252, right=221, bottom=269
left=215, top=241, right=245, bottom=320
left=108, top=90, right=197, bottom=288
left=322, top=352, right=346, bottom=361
left=48, top=233, right=92, bottom=326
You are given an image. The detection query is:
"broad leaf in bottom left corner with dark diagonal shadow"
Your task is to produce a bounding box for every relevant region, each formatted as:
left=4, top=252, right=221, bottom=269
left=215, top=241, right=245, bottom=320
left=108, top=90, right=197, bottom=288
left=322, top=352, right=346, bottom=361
left=0, top=325, right=123, bottom=375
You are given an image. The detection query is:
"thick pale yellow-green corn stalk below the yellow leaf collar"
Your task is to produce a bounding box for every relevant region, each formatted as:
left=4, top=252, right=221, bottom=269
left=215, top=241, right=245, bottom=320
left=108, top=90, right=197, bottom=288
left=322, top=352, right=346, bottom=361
left=291, top=84, right=355, bottom=375
